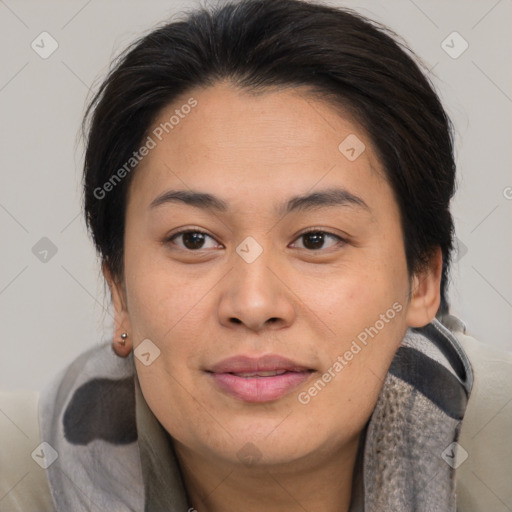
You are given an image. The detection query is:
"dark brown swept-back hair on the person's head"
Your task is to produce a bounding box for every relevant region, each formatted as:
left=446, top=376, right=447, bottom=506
left=83, top=0, right=455, bottom=316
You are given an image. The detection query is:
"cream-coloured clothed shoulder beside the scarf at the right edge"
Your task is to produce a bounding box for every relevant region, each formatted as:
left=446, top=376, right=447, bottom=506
left=453, top=320, right=512, bottom=512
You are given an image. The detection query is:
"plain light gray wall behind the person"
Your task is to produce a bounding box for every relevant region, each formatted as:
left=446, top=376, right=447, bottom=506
left=0, top=0, right=512, bottom=390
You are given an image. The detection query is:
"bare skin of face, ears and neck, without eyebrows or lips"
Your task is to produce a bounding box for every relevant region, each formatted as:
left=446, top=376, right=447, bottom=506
left=103, top=83, right=442, bottom=512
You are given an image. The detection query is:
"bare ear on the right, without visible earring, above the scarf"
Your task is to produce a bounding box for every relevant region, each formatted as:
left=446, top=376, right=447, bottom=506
left=406, top=247, right=443, bottom=327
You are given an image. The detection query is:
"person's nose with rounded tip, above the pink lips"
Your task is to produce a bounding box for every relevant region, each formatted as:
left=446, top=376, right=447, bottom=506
left=218, top=247, right=296, bottom=331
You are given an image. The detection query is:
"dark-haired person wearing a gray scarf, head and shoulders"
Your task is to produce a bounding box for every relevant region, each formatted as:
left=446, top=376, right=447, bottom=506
left=2, top=0, right=512, bottom=512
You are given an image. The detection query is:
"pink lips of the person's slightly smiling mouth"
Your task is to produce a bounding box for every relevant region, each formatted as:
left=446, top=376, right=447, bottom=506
left=209, top=354, right=313, bottom=402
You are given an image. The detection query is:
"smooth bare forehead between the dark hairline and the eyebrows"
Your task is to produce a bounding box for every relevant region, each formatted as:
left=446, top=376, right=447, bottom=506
left=127, top=84, right=385, bottom=214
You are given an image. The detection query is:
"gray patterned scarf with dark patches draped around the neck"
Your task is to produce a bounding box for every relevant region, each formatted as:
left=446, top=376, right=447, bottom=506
left=39, top=320, right=472, bottom=512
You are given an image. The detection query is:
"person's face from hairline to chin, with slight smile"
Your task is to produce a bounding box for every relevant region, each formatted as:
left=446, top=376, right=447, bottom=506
left=107, top=84, right=439, bottom=472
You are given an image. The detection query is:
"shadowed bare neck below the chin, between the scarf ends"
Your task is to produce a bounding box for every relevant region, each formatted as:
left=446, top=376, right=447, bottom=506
left=173, top=435, right=360, bottom=512
